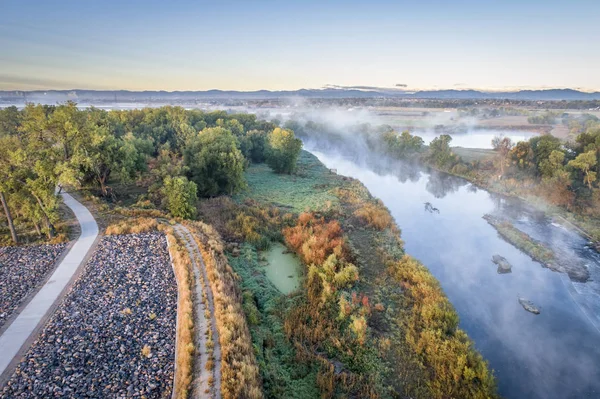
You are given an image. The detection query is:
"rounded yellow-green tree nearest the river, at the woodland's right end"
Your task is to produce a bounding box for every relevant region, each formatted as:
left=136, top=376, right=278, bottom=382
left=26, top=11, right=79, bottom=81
left=266, top=127, right=302, bottom=174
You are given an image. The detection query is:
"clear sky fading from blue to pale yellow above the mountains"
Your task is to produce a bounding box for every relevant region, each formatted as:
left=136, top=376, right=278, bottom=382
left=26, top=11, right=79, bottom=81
left=0, top=0, right=600, bottom=91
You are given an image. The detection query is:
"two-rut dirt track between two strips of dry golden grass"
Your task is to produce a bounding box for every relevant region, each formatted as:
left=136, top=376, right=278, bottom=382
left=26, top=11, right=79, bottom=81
left=174, top=224, right=221, bottom=399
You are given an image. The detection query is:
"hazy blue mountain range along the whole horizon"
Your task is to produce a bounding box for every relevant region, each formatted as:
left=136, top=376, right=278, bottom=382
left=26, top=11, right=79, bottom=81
left=0, top=88, right=600, bottom=103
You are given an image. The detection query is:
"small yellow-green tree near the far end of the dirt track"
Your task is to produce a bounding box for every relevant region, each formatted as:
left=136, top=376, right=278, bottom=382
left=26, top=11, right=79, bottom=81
left=161, top=176, right=198, bottom=219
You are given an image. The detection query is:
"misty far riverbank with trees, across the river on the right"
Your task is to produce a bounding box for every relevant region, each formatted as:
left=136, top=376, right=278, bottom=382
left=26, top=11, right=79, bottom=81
left=287, top=113, right=600, bottom=247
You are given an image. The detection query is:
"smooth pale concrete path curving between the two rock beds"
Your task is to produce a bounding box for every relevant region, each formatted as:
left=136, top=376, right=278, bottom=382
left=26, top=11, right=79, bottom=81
left=0, top=193, right=98, bottom=380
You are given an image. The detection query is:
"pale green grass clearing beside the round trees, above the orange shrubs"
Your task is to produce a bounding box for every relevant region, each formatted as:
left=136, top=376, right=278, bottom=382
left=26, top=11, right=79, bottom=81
left=234, top=151, right=340, bottom=212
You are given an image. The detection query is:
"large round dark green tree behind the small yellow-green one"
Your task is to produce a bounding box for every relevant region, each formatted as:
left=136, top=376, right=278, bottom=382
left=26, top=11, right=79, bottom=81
left=183, top=127, right=246, bottom=197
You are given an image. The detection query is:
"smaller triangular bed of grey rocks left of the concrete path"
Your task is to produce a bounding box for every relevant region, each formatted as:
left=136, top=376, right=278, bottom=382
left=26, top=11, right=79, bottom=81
left=0, top=244, right=67, bottom=328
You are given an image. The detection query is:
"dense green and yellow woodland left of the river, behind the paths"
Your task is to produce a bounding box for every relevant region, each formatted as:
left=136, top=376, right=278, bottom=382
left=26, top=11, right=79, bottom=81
left=0, top=102, right=302, bottom=243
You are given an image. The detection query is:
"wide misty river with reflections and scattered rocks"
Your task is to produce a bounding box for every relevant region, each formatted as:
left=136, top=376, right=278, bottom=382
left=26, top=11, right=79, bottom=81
left=305, top=145, right=600, bottom=399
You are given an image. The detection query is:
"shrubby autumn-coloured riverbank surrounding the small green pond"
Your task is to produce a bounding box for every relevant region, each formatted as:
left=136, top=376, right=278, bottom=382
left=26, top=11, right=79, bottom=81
left=200, top=152, right=496, bottom=398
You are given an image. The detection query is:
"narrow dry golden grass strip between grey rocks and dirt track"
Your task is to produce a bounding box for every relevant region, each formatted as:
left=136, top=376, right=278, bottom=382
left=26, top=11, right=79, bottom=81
left=167, top=231, right=195, bottom=399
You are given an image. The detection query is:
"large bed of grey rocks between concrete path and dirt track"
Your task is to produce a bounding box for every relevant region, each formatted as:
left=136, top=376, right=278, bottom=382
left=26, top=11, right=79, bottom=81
left=0, top=233, right=177, bottom=398
